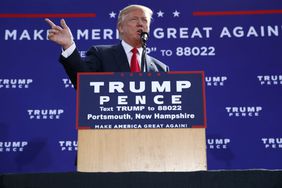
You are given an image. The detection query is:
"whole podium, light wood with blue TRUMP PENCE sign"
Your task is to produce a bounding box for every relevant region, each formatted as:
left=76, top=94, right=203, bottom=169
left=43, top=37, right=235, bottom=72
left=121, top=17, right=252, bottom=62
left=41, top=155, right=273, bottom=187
left=77, top=71, right=207, bottom=172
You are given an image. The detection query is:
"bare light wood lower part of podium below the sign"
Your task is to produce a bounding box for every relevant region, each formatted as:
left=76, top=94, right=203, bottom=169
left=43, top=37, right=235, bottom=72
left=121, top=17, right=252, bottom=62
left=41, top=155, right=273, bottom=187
left=77, top=128, right=207, bottom=172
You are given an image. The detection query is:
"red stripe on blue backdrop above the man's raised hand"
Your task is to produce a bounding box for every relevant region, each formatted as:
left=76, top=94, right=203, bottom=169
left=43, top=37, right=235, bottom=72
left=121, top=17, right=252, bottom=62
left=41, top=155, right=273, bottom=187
left=0, top=13, right=96, bottom=18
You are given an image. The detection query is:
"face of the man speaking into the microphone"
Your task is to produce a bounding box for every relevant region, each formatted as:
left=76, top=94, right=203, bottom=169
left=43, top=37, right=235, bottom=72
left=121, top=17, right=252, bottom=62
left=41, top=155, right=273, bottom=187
left=119, top=9, right=150, bottom=47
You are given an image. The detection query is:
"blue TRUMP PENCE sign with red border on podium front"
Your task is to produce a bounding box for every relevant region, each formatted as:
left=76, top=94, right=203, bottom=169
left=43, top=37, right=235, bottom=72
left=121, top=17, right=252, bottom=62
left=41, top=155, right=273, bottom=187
left=76, top=71, right=206, bottom=129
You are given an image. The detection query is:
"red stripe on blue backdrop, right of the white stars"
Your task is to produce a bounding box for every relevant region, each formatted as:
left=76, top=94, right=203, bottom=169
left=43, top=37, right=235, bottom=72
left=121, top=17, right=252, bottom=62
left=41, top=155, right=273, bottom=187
left=192, top=10, right=282, bottom=16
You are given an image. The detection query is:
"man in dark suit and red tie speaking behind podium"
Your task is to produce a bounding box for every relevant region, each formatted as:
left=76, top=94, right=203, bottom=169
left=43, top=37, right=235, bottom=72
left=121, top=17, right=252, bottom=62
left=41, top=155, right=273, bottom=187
left=45, top=5, right=169, bottom=85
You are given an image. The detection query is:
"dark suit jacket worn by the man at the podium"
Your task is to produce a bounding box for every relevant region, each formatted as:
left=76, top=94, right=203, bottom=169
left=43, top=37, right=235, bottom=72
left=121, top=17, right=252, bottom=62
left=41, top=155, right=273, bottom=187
left=60, top=44, right=169, bottom=88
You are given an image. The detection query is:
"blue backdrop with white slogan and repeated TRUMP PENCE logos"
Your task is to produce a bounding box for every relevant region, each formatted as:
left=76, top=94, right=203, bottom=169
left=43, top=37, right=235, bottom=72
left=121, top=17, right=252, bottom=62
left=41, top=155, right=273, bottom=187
left=0, top=0, right=282, bottom=173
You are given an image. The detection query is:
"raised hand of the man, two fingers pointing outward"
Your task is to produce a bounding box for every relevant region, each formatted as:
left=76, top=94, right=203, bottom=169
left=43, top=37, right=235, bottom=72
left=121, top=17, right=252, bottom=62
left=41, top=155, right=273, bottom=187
left=45, top=18, right=73, bottom=50
